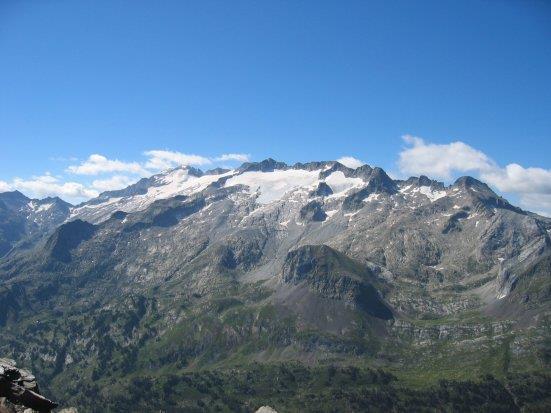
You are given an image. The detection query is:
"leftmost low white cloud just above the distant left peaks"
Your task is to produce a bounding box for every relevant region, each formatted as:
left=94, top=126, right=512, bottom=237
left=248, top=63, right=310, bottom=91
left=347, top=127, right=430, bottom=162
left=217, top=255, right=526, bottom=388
left=9, top=174, right=98, bottom=201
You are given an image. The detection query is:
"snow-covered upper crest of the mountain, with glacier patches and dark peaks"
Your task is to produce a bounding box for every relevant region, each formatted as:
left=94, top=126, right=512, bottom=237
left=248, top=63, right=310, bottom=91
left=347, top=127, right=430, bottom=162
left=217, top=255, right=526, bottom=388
left=69, top=159, right=532, bottom=223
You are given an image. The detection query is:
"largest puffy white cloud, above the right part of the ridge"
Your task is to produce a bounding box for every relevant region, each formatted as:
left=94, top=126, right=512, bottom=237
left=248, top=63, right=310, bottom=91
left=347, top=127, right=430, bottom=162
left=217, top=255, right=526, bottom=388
left=398, top=135, right=495, bottom=179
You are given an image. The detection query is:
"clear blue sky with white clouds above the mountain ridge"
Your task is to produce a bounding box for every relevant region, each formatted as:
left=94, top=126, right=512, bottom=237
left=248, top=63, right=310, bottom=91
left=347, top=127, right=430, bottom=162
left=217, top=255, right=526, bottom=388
left=0, top=0, right=551, bottom=216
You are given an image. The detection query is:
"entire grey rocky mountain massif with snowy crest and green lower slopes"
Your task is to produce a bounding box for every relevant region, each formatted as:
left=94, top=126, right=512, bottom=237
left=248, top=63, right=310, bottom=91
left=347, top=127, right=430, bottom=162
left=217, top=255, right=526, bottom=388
left=0, top=159, right=551, bottom=412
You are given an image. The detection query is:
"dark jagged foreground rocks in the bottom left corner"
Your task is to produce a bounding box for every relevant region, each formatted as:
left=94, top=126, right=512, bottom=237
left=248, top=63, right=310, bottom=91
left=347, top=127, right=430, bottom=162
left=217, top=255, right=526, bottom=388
left=0, top=358, right=57, bottom=413
